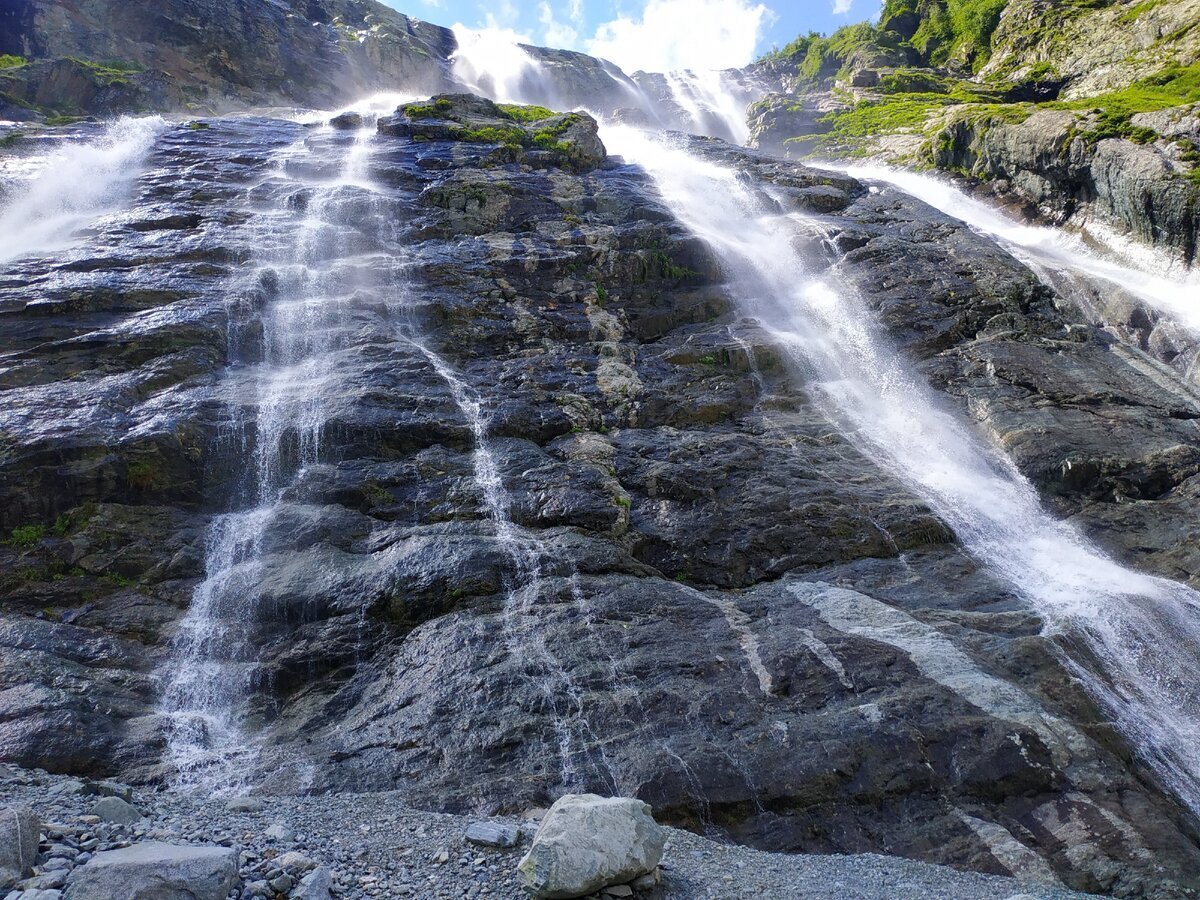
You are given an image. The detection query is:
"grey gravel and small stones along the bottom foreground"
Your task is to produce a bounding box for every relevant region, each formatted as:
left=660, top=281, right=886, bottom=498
left=0, top=766, right=1085, bottom=900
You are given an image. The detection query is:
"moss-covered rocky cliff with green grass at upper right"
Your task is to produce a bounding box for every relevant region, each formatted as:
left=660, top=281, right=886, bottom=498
left=751, top=0, right=1200, bottom=265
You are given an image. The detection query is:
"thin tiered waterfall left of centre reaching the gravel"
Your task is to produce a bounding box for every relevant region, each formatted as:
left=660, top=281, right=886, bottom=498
left=161, top=126, right=401, bottom=790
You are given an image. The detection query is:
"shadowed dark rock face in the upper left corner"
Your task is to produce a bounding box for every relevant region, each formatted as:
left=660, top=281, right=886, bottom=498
left=0, top=0, right=455, bottom=114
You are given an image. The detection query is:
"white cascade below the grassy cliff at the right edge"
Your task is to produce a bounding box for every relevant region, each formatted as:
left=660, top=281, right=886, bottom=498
left=841, top=166, right=1200, bottom=332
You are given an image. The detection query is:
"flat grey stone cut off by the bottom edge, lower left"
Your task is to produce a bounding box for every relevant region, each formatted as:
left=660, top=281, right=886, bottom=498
left=65, top=841, right=238, bottom=900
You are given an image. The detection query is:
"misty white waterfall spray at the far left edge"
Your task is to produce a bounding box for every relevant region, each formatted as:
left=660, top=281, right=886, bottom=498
left=0, top=116, right=167, bottom=263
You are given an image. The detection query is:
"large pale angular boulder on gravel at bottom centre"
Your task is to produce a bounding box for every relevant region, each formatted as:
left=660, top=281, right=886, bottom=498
left=517, top=793, right=666, bottom=900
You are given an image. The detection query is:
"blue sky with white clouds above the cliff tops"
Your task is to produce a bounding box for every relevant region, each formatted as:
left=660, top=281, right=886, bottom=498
left=384, top=0, right=880, bottom=71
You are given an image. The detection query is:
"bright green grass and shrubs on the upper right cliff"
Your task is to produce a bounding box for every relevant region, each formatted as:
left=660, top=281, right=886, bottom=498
left=763, top=0, right=1200, bottom=174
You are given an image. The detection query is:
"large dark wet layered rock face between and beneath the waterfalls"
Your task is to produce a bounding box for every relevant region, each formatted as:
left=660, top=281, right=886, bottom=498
left=0, top=100, right=1200, bottom=896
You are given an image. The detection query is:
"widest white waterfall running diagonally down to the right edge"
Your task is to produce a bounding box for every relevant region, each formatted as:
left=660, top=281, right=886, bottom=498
left=604, top=128, right=1200, bottom=811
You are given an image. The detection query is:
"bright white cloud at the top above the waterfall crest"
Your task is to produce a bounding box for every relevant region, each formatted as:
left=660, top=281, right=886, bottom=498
left=583, top=0, right=772, bottom=72
